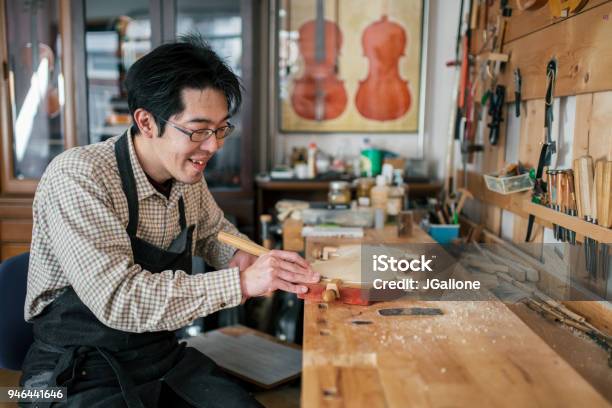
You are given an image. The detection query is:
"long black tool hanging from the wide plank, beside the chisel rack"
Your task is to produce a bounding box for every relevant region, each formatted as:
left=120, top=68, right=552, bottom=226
left=525, top=58, right=557, bottom=242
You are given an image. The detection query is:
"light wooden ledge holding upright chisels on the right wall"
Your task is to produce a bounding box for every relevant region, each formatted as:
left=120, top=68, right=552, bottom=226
left=522, top=200, right=612, bottom=244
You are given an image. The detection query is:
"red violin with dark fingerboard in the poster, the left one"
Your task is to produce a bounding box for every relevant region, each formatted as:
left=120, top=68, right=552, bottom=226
left=291, top=0, right=347, bottom=121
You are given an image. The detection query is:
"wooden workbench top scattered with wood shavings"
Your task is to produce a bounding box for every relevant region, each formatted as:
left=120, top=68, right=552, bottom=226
left=301, top=227, right=609, bottom=408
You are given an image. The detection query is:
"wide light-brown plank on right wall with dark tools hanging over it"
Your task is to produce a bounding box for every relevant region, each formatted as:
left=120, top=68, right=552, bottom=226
left=500, top=2, right=612, bottom=102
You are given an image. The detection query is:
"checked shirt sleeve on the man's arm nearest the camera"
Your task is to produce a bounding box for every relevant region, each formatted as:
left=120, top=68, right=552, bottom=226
left=40, top=168, right=241, bottom=332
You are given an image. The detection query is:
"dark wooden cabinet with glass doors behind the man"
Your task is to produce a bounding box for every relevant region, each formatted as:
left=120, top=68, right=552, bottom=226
left=0, top=0, right=259, bottom=260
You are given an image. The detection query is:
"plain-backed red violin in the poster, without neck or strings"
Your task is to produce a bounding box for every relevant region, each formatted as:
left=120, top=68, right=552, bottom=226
left=355, top=15, right=411, bottom=121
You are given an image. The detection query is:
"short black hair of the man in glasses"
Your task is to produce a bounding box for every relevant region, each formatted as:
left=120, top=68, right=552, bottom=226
left=125, top=33, right=242, bottom=136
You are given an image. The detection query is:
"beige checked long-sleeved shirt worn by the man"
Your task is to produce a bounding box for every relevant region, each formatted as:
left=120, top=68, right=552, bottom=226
left=25, top=132, right=242, bottom=332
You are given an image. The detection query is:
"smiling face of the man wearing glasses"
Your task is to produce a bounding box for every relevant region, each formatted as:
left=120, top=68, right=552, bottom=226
left=152, top=88, right=228, bottom=184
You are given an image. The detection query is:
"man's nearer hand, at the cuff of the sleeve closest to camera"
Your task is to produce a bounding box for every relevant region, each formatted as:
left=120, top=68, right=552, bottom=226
left=240, top=250, right=321, bottom=298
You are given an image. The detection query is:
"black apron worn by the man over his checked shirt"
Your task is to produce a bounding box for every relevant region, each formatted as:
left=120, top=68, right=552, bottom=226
left=21, top=134, right=261, bottom=408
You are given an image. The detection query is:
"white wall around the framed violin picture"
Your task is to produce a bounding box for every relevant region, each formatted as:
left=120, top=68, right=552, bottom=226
left=260, top=0, right=460, bottom=179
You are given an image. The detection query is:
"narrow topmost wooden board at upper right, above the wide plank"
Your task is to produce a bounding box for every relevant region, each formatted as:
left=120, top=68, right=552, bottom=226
left=504, top=0, right=611, bottom=43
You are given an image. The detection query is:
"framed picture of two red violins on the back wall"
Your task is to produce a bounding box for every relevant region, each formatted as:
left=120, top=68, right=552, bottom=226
left=276, top=0, right=427, bottom=133
